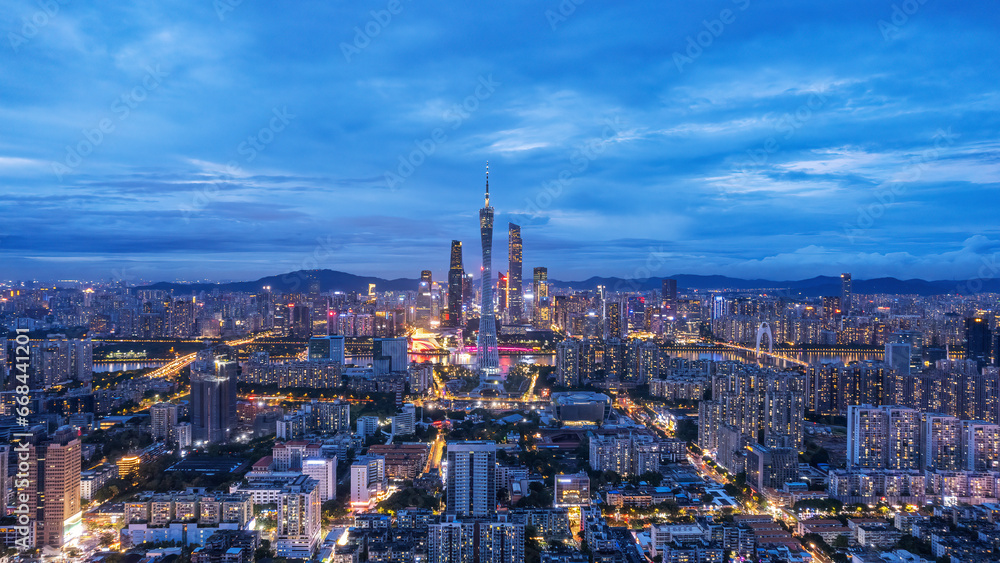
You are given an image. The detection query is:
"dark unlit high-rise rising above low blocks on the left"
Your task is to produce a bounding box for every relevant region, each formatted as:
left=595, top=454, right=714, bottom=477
left=191, top=356, right=237, bottom=444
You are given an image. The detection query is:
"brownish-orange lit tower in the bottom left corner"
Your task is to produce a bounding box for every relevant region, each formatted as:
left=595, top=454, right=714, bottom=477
left=26, top=426, right=81, bottom=547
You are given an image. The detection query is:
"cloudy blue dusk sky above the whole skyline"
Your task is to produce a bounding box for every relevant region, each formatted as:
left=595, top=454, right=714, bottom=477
left=0, top=0, right=1000, bottom=281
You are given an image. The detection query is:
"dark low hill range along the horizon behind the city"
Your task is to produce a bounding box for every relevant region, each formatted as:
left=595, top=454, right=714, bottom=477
left=140, top=270, right=1000, bottom=297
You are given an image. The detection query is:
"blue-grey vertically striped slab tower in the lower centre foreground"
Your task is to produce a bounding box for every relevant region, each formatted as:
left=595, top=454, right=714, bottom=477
left=447, top=441, right=497, bottom=518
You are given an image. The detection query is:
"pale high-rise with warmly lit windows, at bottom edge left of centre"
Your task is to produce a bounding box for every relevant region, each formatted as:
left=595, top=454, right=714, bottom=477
left=275, top=475, right=323, bottom=559
